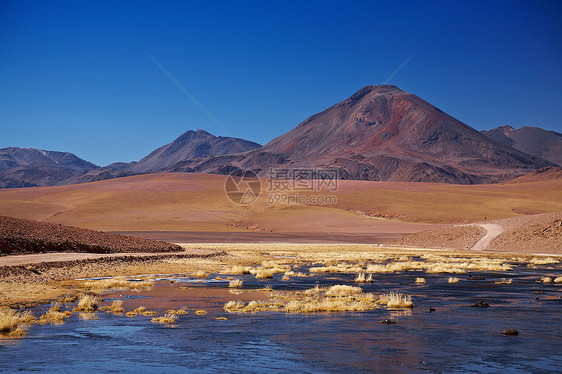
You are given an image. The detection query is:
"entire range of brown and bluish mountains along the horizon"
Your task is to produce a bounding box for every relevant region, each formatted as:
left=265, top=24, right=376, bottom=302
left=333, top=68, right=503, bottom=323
left=0, top=85, right=562, bottom=188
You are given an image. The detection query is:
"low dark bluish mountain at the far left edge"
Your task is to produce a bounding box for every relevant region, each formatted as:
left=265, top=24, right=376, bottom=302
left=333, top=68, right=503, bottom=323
left=0, top=147, right=98, bottom=188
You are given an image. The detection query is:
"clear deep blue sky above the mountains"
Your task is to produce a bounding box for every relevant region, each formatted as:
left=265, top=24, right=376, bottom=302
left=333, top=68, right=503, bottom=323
left=0, top=0, right=562, bottom=165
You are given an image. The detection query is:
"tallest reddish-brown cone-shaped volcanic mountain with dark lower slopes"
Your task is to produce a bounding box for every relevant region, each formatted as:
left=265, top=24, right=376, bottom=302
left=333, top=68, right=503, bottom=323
left=170, top=85, right=553, bottom=184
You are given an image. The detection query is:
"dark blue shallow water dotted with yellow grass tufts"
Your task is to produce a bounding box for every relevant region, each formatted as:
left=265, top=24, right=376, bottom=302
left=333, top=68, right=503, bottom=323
left=0, top=265, right=562, bottom=373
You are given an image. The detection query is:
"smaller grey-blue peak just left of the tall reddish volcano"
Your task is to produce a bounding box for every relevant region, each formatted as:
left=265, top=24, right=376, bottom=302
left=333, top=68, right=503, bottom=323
left=127, top=129, right=261, bottom=173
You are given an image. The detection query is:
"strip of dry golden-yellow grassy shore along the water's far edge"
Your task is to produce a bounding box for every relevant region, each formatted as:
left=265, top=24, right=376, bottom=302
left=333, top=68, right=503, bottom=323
left=0, top=243, right=562, bottom=309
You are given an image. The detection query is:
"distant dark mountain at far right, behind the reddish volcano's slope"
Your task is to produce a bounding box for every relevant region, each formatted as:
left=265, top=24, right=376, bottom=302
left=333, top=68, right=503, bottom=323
left=482, top=126, right=562, bottom=166
